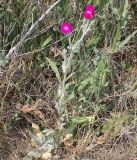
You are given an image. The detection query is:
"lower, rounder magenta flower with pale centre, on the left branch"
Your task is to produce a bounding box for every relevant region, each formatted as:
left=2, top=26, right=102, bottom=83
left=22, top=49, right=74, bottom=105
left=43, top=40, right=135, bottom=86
left=60, top=22, right=73, bottom=35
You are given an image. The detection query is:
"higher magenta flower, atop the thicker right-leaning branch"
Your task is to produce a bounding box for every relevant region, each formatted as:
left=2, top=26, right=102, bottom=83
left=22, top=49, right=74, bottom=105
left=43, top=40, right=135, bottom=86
left=83, top=5, right=95, bottom=19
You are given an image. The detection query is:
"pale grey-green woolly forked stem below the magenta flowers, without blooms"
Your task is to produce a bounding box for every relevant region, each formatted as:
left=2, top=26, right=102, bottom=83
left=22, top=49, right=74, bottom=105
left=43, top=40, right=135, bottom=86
left=58, top=21, right=93, bottom=135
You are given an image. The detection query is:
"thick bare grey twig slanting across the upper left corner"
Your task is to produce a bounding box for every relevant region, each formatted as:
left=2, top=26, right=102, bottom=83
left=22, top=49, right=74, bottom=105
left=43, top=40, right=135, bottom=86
left=5, top=0, right=61, bottom=62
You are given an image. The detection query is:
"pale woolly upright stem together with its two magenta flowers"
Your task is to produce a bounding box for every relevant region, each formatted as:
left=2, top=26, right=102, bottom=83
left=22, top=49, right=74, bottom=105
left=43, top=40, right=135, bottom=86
left=56, top=4, right=94, bottom=144
